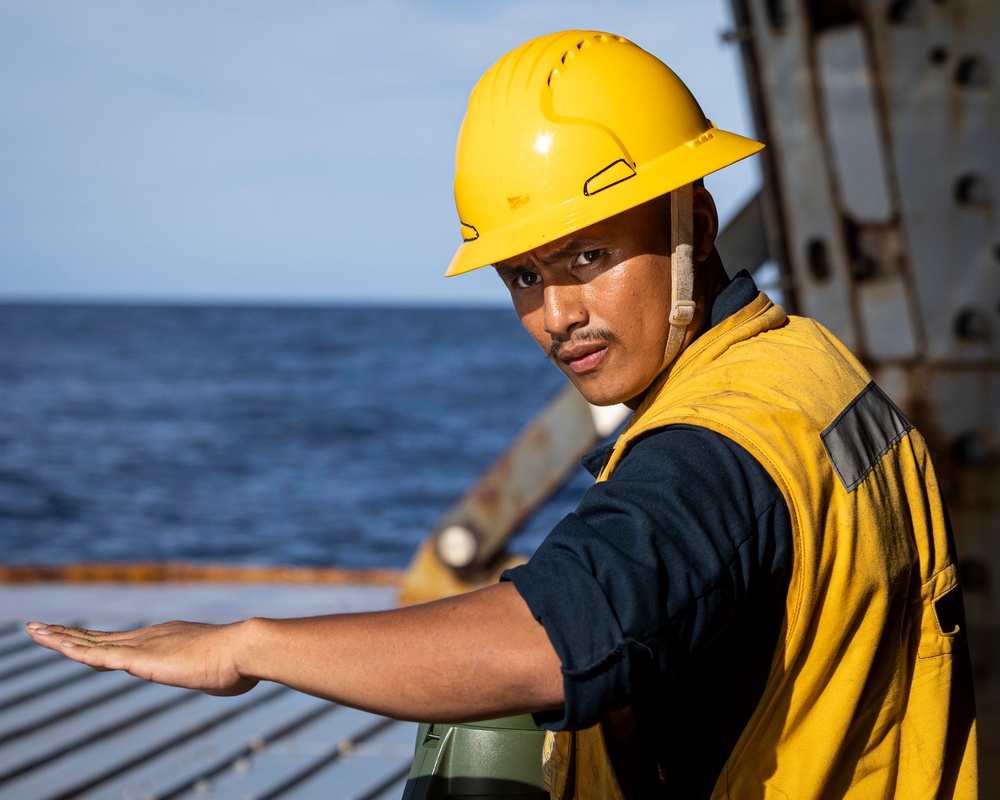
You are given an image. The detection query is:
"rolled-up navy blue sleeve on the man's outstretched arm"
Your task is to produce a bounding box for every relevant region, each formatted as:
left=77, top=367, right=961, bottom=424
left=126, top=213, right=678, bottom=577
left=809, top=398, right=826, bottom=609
left=501, top=425, right=790, bottom=730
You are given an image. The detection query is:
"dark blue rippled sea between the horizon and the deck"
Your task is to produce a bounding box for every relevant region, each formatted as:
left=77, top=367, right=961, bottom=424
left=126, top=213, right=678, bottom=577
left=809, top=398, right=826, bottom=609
left=0, top=304, right=590, bottom=567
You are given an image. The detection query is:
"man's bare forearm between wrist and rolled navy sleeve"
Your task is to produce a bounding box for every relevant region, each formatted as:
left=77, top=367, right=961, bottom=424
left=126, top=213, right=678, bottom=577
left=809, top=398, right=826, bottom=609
left=234, top=584, right=562, bottom=721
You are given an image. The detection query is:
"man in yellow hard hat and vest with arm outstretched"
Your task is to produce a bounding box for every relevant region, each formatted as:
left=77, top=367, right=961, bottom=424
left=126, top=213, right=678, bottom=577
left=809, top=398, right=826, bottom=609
left=28, top=31, right=976, bottom=798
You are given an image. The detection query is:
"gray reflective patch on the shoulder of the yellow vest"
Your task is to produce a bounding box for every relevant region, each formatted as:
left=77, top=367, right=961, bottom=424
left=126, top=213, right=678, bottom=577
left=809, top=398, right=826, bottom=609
left=820, top=382, right=913, bottom=492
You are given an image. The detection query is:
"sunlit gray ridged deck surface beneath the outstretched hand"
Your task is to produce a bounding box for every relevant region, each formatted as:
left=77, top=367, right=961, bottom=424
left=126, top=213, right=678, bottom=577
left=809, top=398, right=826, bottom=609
left=0, top=582, right=416, bottom=800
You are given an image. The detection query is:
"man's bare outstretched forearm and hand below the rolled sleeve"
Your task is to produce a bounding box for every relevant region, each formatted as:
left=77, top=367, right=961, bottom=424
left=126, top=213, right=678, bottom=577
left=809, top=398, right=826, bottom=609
left=27, top=583, right=563, bottom=722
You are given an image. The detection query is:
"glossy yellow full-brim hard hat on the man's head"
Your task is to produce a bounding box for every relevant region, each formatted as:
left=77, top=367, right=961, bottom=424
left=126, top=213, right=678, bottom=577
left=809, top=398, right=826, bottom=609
left=445, top=31, right=763, bottom=275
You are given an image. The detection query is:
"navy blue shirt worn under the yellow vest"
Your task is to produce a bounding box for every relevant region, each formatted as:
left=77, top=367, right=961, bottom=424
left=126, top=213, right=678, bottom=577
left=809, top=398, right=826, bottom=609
left=502, top=273, right=791, bottom=797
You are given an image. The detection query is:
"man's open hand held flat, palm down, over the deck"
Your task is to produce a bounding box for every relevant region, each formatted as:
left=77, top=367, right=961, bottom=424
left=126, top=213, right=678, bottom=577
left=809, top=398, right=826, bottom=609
left=27, top=622, right=257, bottom=695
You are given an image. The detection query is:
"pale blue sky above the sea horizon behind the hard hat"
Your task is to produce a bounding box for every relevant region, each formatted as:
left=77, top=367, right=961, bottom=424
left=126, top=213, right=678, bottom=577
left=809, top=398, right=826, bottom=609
left=0, top=0, right=759, bottom=303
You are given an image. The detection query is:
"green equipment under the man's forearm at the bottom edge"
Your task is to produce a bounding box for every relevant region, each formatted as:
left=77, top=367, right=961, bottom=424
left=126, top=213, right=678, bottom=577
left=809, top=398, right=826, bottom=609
left=403, top=714, right=549, bottom=800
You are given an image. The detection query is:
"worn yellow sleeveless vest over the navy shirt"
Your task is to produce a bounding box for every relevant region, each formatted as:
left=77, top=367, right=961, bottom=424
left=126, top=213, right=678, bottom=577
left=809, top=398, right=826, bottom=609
left=550, top=293, right=977, bottom=800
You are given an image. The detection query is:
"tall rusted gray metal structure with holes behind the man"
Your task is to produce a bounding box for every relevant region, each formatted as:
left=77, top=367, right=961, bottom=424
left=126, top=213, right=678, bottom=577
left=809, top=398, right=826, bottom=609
left=731, top=0, right=1000, bottom=629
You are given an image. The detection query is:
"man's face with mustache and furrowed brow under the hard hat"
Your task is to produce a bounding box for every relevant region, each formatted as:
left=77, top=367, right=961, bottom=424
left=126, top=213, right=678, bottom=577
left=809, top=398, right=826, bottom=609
left=495, top=199, right=670, bottom=405
